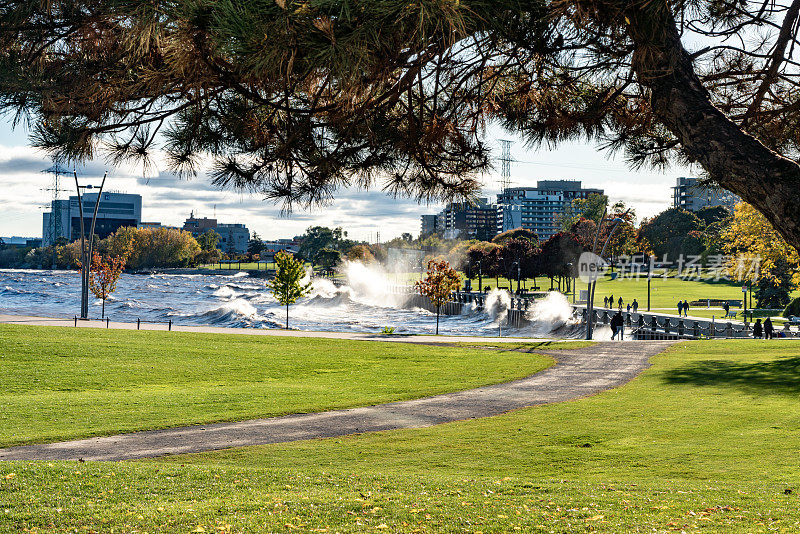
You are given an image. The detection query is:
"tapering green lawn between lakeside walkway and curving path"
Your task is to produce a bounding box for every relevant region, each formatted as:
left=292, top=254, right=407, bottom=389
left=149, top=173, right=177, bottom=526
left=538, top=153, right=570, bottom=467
left=0, top=325, right=551, bottom=446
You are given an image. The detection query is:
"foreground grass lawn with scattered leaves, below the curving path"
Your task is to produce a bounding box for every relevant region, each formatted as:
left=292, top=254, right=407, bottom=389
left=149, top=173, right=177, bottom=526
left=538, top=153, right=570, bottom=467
left=0, top=341, right=800, bottom=533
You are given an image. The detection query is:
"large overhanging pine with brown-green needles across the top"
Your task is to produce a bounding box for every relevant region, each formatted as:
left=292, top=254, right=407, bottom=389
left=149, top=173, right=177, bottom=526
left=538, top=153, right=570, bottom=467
left=0, top=0, right=800, bottom=251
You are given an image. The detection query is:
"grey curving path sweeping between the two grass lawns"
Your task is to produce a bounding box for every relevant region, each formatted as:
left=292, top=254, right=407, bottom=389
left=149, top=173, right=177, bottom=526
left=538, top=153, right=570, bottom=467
left=0, top=341, right=673, bottom=461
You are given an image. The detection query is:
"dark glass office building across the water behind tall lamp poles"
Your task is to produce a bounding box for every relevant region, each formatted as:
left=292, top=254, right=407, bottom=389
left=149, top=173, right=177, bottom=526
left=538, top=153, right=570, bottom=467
left=42, top=192, right=142, bottom=246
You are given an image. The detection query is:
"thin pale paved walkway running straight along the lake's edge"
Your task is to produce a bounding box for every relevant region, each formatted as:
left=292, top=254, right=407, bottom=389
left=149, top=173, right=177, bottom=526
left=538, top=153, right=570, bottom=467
left=0, top=313, right=568, bottom=344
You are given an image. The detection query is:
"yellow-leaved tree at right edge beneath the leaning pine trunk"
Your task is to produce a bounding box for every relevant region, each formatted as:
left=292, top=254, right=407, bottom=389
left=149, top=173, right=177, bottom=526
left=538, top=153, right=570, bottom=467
left=721, top=203, right=800, bottom=308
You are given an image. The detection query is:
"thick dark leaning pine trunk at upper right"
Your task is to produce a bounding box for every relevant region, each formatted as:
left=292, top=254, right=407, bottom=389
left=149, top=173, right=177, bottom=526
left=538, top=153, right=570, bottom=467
left=626, top=2, right=800, bottom=248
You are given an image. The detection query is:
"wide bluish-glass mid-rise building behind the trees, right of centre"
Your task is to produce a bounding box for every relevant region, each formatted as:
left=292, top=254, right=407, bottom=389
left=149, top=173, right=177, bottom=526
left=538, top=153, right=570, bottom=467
left=497, top=180, right=603, bottom=241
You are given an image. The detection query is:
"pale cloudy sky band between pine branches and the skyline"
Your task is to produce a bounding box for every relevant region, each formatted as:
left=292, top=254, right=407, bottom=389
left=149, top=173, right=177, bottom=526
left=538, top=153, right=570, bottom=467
left=0, top=119, right=691, bottom=240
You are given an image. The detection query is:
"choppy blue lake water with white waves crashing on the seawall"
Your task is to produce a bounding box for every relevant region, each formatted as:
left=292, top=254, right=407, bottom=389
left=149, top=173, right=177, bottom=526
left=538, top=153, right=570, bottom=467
left=0, top=263, right=577, bottom=337
